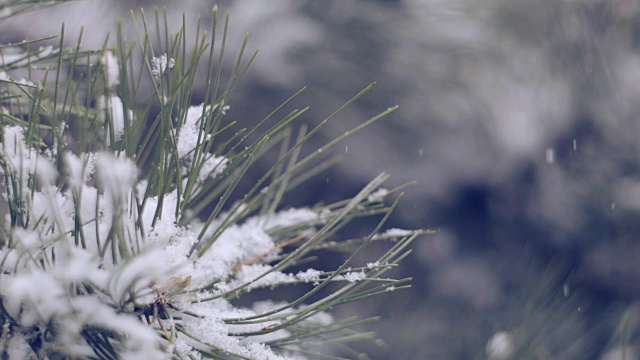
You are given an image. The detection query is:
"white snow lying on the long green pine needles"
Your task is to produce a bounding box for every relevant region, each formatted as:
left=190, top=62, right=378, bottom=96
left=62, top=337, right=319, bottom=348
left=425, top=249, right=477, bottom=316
left=0, top=91, right=384, bottom=360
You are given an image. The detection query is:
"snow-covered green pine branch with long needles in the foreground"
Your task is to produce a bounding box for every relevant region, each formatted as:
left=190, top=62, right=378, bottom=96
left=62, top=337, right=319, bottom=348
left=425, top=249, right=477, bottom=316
left=0, top=3, right=420, bottom=359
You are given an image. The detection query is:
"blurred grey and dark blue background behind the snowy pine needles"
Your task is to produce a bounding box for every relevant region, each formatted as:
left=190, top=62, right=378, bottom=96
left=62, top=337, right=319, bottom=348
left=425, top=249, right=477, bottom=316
left=0, top=0, right=640, bottom=360
